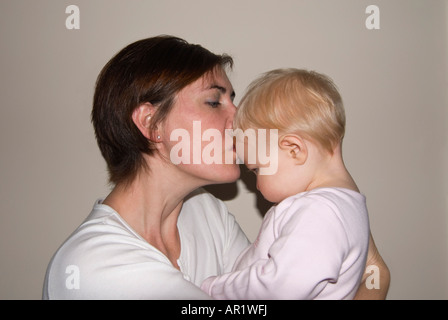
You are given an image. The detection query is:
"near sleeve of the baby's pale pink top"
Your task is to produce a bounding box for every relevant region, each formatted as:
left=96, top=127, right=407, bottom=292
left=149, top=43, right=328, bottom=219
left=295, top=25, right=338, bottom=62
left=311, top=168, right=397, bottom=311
left=202, top=201, right=348, bottom=299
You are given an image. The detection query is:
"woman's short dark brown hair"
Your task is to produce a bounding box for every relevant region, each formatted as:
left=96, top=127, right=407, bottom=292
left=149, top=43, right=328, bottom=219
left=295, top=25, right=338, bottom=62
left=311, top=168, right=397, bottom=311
left=91, top=36, right=233, bottom=184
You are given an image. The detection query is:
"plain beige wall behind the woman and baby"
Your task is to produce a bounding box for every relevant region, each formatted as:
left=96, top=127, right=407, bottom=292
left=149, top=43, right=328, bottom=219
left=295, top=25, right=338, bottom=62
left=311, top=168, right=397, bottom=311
left=0, top=0, right=448, bottom=299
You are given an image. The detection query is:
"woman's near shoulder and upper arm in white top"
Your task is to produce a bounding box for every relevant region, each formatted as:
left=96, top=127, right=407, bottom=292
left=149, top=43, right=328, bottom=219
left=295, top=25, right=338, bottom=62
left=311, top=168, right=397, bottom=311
left=44, top=203, right=196, bottom=299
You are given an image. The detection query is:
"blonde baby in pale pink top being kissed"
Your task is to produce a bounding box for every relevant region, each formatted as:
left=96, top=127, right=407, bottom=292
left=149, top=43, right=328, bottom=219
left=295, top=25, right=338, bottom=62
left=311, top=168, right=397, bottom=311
left=202, top=69, right=369, bottom=299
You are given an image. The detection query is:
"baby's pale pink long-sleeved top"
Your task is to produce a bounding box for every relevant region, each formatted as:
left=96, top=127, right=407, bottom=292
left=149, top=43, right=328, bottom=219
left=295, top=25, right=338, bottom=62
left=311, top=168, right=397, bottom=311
left=202, top=188, right=369, bottom=299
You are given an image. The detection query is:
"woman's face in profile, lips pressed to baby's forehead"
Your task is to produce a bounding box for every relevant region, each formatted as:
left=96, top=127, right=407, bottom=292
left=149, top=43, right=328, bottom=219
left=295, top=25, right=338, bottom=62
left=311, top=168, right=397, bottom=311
left=160, top=68, right=240, bottom=185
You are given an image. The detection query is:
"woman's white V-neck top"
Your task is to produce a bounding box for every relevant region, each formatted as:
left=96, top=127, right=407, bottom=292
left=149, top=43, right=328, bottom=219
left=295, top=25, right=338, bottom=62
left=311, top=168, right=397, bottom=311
left=43, top=190, right=249, bottom=299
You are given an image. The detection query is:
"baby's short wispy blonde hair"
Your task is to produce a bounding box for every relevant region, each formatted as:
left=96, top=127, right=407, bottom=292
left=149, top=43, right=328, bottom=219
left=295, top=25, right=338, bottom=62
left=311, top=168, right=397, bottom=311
left=234, top=69, right=345, bottom=153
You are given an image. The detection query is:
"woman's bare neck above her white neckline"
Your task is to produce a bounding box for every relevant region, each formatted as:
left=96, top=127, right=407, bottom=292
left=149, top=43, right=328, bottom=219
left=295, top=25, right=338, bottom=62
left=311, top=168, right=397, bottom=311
left=103, top=155, right=201, bottom=268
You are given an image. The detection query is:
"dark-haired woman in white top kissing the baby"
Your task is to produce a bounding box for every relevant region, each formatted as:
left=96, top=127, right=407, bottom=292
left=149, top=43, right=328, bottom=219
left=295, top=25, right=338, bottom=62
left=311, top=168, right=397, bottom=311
left=43, top=36, right=388, bottom=299
